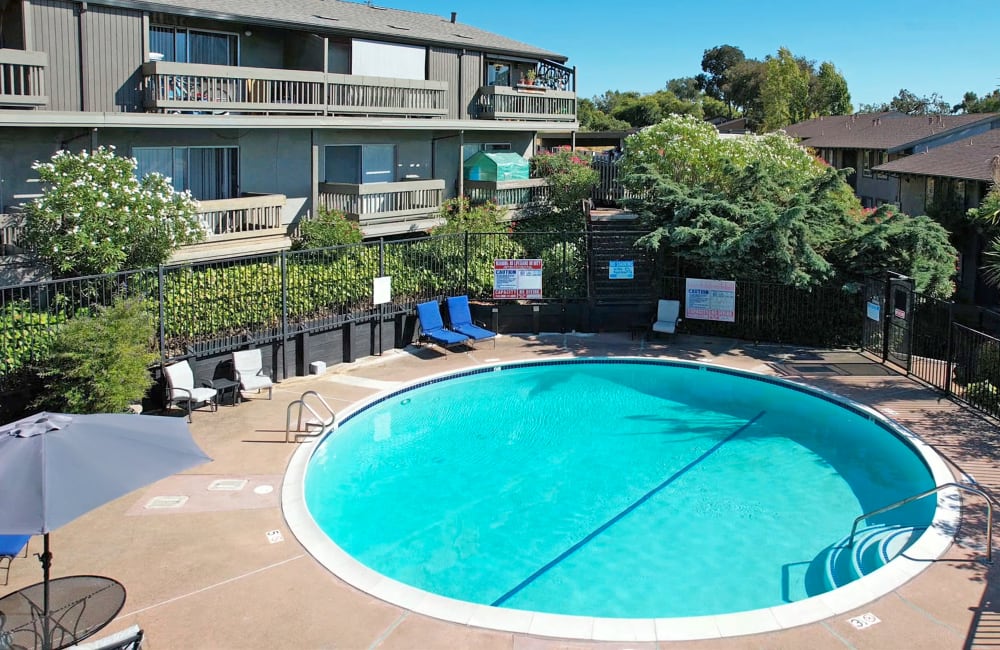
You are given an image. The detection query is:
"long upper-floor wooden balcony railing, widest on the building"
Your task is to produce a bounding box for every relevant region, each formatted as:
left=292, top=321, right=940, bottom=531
left=142, top=61, right=448, bottom=117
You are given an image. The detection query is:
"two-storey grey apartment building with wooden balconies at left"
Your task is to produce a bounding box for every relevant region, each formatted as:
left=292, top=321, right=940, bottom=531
left=0, top=0, right=578, bottom=258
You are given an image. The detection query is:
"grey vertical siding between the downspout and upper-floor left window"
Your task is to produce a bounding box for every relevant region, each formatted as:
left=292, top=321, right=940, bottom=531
left=83, top=5, right=143, bottom=113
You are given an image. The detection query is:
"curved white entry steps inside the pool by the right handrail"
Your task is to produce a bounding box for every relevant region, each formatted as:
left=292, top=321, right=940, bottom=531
left=826, top=524, right=927, bottom=589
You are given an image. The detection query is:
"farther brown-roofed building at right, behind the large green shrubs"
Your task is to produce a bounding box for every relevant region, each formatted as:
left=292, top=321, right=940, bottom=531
left=785, top=112, right=1000, bottom=208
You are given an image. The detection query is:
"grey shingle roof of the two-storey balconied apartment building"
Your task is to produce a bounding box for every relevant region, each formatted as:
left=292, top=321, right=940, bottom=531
left=112, top=0, right=566, bottom=62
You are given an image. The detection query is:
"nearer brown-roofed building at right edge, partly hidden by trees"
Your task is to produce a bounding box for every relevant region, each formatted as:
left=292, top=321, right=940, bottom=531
left=873, top=129, right=1000, bottom=305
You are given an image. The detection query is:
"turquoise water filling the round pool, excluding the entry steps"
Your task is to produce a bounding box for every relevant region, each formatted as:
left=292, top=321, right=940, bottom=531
left=304, top=360, right=934, bottom=618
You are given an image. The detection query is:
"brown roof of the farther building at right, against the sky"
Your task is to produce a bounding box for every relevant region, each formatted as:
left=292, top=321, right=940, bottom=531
left=785, top=112, right=998, bottom=149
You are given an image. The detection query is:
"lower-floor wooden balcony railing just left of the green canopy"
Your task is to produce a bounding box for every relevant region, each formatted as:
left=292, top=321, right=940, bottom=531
left=319, top=179, right=445, bottom=228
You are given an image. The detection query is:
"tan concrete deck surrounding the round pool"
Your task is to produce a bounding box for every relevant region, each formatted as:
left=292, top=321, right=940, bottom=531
left=7, top=334, right=1000, bottom=650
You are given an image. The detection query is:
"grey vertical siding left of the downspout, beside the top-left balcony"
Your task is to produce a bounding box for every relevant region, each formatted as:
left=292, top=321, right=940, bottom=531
left=31, top=0, right=83, bottom=111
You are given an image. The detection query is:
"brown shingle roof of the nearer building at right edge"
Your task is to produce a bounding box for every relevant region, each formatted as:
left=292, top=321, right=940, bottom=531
left=875, top=129, right=1000, bottom=182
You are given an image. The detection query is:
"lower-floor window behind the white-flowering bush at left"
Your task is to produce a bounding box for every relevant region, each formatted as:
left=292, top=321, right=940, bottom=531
left=132, top=147, right=239, bottom=201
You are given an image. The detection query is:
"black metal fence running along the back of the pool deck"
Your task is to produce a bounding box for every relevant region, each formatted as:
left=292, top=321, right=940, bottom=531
left=9, top=231, right=1000, bottom=416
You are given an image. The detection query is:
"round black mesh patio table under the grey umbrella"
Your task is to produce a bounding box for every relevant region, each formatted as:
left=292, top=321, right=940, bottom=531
left=0, top=576, right=125, bottom=650
